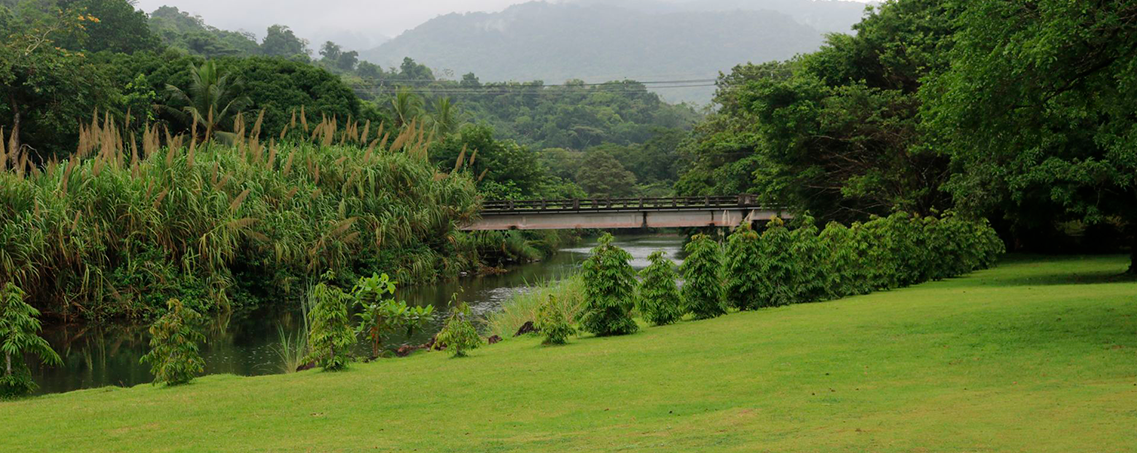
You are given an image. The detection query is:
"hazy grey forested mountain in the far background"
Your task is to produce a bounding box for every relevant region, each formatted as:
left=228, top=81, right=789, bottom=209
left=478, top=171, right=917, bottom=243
left=360, top=2, right=864, bottom=102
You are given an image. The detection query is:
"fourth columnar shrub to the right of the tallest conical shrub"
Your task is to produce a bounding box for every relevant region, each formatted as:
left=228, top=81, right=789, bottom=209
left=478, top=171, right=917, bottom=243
left=758, top=217, right=803, bottom=307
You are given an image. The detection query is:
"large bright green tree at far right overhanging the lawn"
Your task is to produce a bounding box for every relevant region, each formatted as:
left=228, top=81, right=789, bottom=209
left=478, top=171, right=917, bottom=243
left=922, top=0, right=1137, bottom=274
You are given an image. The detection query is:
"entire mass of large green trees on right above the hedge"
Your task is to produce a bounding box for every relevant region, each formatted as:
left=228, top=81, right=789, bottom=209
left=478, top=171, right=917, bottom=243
left=675, top=0, right=1137, bottom=265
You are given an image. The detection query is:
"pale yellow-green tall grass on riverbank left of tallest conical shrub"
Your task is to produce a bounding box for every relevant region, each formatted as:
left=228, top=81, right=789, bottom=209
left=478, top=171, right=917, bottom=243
left=487, top=275, right=584, bottom=338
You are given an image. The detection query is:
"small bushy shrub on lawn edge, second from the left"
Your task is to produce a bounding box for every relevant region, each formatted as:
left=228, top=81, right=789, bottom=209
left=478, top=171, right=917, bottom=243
left=140, top=299, right=206, bottom=386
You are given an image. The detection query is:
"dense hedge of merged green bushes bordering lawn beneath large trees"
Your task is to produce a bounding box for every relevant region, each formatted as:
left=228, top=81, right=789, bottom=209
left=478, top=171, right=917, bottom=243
left=741, top=213, right=1005, bottom=307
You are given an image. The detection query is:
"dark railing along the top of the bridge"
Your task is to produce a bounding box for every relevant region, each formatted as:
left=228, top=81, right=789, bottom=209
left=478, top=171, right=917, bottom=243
left=482, top=195, right=762, bottom=213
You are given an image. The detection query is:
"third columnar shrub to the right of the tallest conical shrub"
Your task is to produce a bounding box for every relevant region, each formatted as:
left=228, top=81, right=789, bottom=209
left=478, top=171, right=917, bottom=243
left=724, top=222, right=762, bottom=311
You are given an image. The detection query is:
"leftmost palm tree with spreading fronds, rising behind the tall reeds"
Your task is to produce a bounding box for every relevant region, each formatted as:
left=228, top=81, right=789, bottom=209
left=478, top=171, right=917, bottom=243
left=165, top=60, right=251, bottom=135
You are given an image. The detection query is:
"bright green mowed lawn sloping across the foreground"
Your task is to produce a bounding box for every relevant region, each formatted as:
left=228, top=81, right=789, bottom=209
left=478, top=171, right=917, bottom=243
left=0, top=257, right=1137, bottom=452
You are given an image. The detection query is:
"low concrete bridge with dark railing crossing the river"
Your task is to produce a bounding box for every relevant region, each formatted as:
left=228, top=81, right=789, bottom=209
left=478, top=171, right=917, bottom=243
left=463, top=195, right=787, bottom=231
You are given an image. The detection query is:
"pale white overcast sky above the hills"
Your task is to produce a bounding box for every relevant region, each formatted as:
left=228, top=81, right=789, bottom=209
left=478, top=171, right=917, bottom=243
left=135, top=0, right=866, bottom=50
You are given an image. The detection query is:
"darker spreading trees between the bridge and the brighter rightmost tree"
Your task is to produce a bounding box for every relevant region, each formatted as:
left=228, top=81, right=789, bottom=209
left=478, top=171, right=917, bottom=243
left=682, top=0, right=951, bottom=221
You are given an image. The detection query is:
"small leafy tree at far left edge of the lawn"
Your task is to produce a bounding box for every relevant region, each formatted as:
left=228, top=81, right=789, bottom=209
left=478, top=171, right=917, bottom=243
left=0, top=281, right=63, bottom=398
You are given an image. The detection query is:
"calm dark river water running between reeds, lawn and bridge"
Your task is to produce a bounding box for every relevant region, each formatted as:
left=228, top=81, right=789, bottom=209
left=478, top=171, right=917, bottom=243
left=30, top=236, right=683, bottom=394
